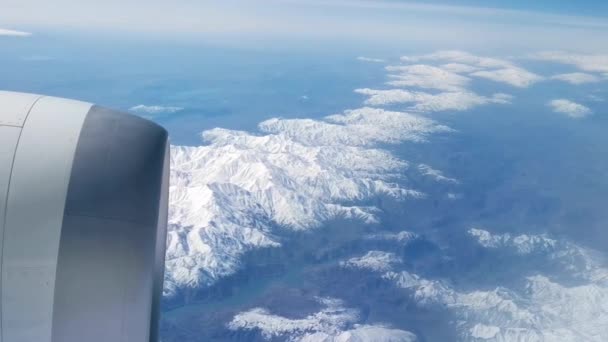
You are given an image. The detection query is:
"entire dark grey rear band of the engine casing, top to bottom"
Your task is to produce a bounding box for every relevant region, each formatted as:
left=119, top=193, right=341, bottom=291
left=53, top=106, right=168, bottom=342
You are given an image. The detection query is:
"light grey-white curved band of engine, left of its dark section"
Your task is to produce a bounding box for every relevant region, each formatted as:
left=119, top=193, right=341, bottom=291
left=2, top=97, right=91, bottom=342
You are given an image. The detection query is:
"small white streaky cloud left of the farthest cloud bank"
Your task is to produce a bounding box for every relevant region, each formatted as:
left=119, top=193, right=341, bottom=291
left=386, top=64, right=470, bottom=91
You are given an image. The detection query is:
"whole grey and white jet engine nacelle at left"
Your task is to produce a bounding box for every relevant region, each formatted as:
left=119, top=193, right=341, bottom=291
left=0, top=92, right=169, bottom=342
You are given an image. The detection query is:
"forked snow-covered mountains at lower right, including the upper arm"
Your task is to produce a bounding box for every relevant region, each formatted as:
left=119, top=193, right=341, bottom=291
left=343, top=229, right=608, bottom=342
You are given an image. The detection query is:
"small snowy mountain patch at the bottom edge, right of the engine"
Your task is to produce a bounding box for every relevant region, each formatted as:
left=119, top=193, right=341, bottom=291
left=228, top=298, right=417, bottom=342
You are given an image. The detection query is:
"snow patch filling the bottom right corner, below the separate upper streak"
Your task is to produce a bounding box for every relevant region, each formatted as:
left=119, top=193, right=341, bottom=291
left=384, top=271, right=608, bottom=342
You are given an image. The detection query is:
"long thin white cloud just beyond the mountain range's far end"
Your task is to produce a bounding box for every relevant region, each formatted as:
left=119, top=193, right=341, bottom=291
left=355, top=88, right=511, bottom=112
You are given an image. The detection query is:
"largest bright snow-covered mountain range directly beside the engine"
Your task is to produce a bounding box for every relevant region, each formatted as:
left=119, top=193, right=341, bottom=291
left=165, top=108, right=450, bottom=296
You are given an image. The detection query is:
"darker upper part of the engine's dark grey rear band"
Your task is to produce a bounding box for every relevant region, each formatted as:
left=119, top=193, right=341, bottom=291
left=66, top=106, right=167, bottom=225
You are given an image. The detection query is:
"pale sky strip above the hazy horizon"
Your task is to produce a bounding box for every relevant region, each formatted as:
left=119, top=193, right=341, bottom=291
left=0, top=0, right=608, bottom=52
